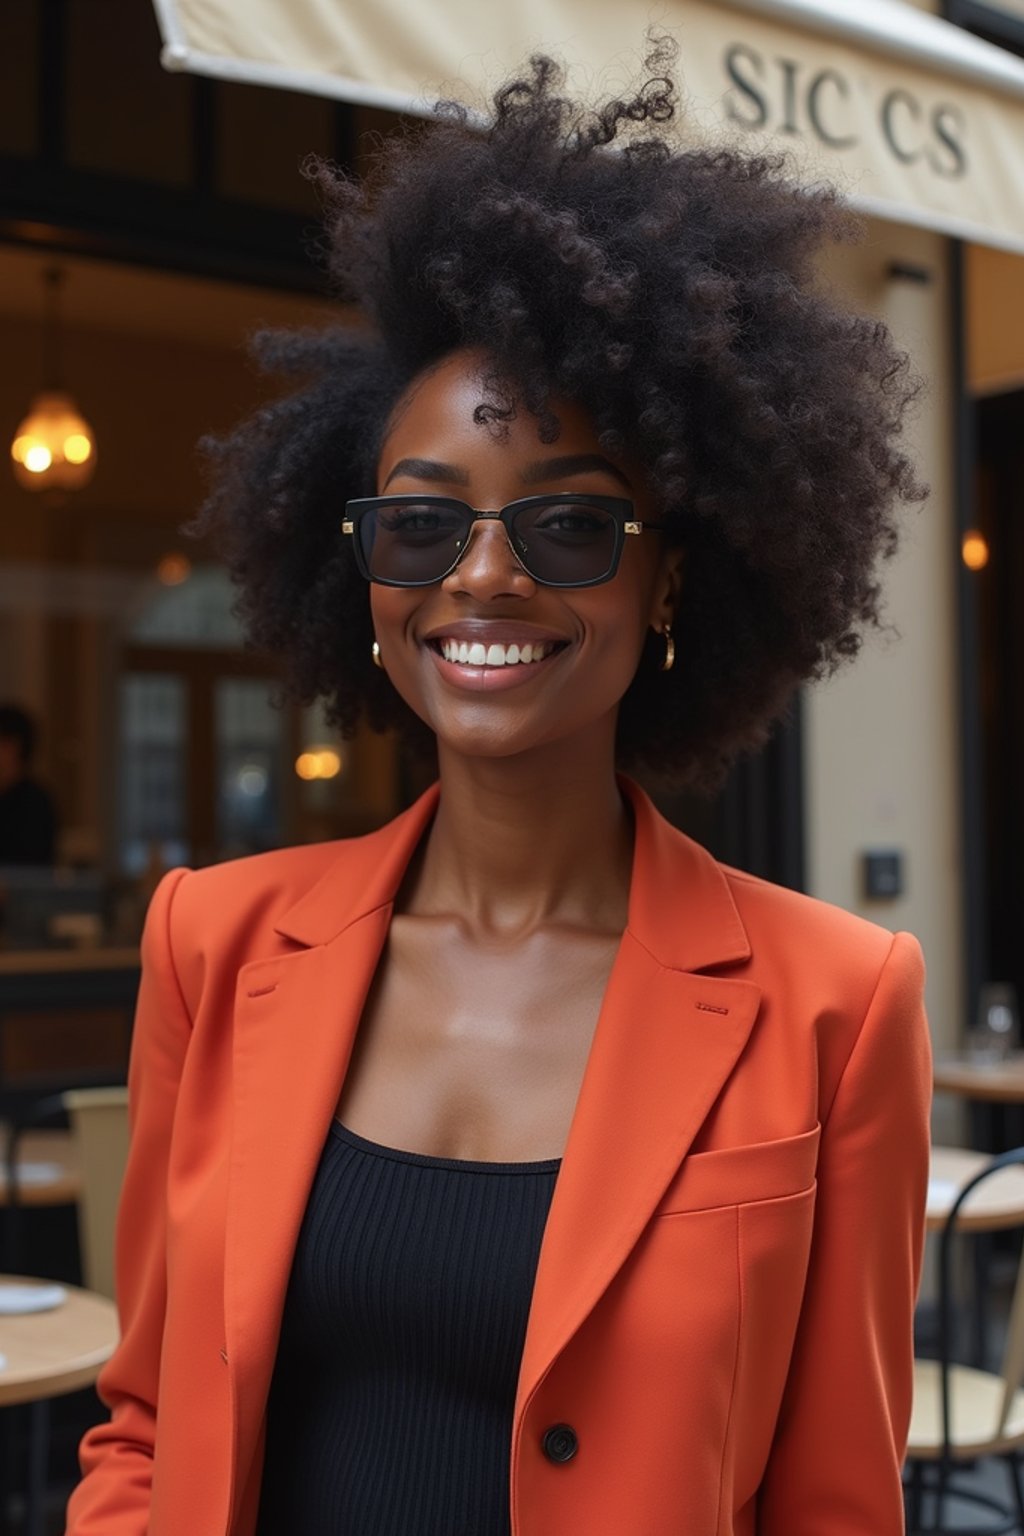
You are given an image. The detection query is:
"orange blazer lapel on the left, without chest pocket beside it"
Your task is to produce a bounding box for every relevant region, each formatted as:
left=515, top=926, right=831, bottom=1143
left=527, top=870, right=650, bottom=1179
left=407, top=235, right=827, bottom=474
left=224, top=786, right=438, bottom=1498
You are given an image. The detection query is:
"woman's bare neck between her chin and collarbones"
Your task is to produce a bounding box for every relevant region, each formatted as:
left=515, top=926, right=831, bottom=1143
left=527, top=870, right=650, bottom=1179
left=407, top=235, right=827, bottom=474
left=404, top=740, right=633, bottom=938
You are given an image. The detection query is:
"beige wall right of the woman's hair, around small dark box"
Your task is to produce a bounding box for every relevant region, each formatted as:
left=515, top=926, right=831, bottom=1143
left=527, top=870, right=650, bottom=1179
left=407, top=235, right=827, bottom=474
left=806, top=223, right=964, bottom=1130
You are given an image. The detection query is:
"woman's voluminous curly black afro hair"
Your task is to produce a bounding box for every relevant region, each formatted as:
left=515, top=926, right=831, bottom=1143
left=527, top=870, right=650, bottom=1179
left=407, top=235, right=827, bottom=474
left=189, top=38, right=926, bottom=788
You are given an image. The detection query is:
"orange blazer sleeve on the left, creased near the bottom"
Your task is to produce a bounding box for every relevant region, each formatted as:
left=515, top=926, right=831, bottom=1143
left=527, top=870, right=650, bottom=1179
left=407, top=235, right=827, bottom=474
left=66, top=869, right=190, bottom=1536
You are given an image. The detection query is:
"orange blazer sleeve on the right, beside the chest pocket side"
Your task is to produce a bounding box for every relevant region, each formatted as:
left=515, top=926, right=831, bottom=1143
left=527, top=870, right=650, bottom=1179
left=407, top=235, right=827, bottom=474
left=757, top=934, right=932, bottom=1536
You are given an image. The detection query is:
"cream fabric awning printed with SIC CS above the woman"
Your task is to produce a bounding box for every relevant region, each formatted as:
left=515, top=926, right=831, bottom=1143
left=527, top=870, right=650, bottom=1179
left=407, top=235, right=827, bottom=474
left=155, top=0, right=1024, bottom=253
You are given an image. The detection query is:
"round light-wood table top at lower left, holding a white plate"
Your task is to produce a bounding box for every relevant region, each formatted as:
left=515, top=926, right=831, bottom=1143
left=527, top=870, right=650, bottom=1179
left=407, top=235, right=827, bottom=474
left=0, top=1275, right=118, bottom=1407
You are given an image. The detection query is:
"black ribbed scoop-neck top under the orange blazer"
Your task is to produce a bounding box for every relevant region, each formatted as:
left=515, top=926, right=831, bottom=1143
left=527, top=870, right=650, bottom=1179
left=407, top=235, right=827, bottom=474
left=258, top=1121, right=559, bottom=1536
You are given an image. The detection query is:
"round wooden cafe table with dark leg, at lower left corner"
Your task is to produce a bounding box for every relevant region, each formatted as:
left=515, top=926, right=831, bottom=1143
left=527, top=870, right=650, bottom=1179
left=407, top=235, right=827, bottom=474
left=0, top=1275, right=118, bottom=1536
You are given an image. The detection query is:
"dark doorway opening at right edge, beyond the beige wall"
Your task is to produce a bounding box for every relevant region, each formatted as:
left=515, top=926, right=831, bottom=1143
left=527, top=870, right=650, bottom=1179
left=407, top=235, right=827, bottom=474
left=973, top=390, right=1024, bottom=1000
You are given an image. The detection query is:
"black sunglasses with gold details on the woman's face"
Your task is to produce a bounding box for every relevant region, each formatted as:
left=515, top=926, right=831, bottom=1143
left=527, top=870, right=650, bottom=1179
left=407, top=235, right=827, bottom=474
left=341, top=495, right=665, bottom=587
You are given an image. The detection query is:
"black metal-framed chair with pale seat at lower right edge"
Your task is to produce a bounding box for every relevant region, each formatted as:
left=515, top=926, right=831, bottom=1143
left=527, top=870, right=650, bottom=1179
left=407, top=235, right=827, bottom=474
left=906, top=1147, right=1024, bottom=1536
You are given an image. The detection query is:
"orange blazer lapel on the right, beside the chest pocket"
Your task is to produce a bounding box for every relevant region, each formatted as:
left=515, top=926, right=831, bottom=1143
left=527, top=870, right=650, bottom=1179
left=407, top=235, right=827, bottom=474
left=516, top=779, right=760, bottom=1424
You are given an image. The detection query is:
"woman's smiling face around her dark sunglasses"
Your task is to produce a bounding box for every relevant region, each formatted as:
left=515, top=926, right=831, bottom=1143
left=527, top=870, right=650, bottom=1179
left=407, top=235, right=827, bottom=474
left=363, top=350, right=682, bottom=757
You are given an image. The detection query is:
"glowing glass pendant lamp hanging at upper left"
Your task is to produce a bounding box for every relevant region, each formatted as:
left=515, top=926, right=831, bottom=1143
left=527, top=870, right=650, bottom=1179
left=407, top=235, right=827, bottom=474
left=11, top=267, right=97, bottom=490
